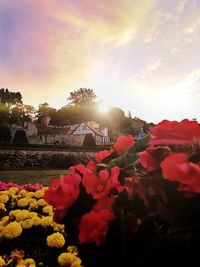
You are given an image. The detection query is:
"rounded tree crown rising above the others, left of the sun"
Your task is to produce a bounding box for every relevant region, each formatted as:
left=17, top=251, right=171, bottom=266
left=67, top=88, right=96, bottom=105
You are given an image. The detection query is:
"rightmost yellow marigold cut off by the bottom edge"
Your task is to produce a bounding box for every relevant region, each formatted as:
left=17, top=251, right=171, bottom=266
left=58, top=252, right=81, bottom=267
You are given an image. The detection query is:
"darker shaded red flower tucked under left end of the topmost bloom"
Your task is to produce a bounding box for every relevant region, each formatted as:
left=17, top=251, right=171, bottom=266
left=139, top=146, right=170, bottom=172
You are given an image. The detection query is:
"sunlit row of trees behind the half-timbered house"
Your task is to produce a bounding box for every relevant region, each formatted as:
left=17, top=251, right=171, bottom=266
left=0, top=88, right=145, bottom=135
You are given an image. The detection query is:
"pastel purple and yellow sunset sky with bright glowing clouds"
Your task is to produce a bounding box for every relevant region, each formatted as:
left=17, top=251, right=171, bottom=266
left=0, top=0, right=200, bottom=123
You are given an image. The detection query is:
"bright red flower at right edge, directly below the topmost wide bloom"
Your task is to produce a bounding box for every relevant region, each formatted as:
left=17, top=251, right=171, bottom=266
left=161, top=153, right=200, bottom=185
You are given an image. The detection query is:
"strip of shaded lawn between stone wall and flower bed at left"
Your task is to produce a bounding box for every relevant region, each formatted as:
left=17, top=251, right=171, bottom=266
left=0, top=170, right=68, bottom=185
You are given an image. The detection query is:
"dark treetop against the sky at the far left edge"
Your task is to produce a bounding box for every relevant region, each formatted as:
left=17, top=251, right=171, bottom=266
left=0, top=88, right=22, bottom=106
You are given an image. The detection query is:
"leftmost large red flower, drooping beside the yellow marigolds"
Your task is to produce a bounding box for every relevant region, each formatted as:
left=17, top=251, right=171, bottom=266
left=44, top=173, right=81, bottom=222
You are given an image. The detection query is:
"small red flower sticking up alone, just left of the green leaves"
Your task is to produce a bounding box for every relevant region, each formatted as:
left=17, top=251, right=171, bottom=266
left=114, top=135, right=135, bottom=154
